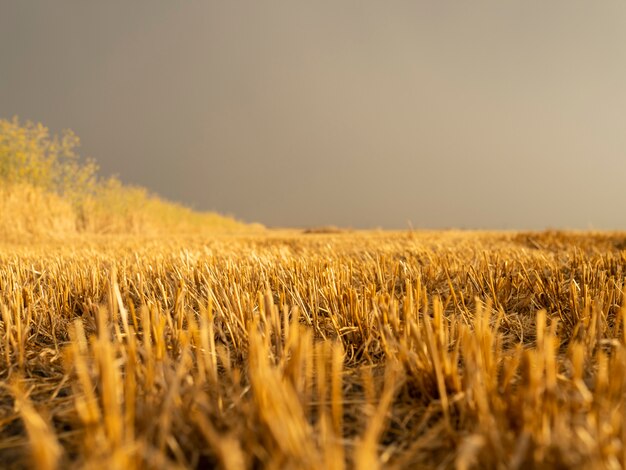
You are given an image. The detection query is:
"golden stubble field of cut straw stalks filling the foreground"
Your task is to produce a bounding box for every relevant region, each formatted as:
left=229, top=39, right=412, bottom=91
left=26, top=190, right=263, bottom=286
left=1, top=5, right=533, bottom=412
left=0, top=231, right=626, bottom=469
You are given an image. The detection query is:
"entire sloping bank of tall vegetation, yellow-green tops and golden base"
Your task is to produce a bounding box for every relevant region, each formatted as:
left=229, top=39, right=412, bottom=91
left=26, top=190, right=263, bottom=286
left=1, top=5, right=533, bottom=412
left=0, top=118, right=242, bottom=239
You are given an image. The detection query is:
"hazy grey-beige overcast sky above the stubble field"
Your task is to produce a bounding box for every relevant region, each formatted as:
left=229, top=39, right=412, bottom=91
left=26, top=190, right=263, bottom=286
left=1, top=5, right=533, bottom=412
left=0, top=0, right=626, bottom=229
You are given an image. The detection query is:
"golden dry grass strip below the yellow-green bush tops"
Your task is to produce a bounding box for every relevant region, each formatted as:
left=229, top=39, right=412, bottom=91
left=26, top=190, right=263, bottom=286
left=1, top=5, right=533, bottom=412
left=0, top=184, right=249, bottom=243
